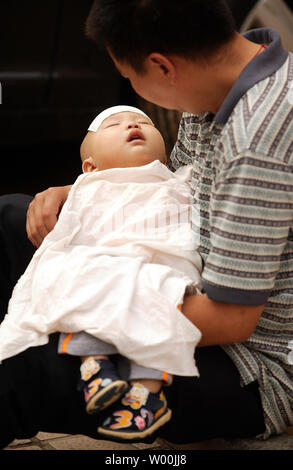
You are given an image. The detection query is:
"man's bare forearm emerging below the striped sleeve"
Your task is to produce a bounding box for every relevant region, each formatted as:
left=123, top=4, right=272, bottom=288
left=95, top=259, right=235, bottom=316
left=182, top=294, right=264, bottom=346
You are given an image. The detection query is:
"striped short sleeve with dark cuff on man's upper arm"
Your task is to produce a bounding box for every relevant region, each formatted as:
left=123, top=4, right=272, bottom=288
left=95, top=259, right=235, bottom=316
left=202, top=150, right=293, bottom=305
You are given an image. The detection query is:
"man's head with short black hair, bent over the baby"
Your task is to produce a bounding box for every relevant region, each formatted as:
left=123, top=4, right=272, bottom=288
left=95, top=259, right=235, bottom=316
left=86, top=0, right=236, bottom=113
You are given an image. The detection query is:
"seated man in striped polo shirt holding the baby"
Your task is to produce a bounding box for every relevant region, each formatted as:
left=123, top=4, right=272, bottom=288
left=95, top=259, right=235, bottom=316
left=0, top=0, right=293, bottom=448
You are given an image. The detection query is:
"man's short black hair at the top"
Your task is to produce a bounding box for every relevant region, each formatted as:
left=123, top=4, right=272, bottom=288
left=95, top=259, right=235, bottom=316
left=86, top=0, right=235, bottom=73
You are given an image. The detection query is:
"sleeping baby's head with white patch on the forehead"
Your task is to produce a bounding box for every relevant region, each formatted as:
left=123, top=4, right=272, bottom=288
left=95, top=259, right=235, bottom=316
left=80, top=106, right=167, bottom=172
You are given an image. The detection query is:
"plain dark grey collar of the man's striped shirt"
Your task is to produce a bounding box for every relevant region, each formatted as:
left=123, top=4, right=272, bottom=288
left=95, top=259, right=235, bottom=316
left=214, top=28, right=289, bottom=124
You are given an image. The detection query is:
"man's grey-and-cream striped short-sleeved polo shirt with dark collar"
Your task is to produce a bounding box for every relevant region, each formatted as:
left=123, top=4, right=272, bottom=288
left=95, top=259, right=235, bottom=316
left=171, top=28, right=293, bottom=439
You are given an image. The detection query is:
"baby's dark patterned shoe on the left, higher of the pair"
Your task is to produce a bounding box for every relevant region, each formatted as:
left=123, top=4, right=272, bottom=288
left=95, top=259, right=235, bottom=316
left=80, top=357, right=129, bottom=414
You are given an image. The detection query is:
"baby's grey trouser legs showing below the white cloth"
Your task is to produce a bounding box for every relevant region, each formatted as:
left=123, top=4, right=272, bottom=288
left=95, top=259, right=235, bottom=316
left=58, top=331, right=172, bottom=382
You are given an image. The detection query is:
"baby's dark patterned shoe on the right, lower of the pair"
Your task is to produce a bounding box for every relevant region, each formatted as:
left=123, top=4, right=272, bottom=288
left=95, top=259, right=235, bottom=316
left=98, top=383, right=172, bottom=442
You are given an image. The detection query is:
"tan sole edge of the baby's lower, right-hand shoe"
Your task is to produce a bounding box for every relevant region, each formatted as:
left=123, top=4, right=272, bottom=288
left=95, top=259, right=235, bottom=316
left=97, top=409, right=172, bottom=442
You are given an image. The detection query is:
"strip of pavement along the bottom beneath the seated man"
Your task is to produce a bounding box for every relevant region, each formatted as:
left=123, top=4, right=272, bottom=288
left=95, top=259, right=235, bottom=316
left=3, top=427, right=293, bottom=452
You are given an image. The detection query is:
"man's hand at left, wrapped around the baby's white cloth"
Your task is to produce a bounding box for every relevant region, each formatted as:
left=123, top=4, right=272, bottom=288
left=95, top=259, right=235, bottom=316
left=26, top=185, right=71, bottom=248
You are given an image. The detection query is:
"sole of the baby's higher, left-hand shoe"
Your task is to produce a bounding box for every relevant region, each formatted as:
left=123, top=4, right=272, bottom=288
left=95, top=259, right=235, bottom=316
left=86, top=380, right=129, bottom=414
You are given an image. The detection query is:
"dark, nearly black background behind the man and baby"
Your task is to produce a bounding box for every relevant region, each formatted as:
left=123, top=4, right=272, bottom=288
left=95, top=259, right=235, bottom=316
left=0, top=0, right=293, bottom=195
